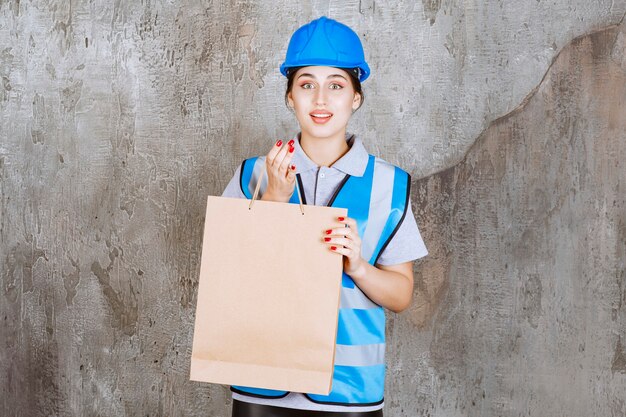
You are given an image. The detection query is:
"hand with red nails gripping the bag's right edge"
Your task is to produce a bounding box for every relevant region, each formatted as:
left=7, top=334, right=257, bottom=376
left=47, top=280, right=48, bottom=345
left=324, top=217, right=367, bottom=278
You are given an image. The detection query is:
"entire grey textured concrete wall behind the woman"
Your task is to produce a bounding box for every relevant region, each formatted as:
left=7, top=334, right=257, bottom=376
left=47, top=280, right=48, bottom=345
left=0, top=0, right=626, bottom=417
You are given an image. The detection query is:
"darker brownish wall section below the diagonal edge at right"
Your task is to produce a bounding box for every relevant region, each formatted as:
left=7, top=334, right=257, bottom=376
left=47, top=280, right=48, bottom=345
left=398, top=23, right=626, bottom=417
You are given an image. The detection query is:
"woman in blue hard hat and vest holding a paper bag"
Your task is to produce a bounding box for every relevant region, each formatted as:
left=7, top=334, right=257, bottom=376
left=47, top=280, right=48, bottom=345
left=223, top=17, right=427, bottom=417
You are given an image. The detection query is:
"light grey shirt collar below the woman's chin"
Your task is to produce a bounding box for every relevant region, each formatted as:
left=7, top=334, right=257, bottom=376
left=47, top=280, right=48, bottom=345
left=291, top=133, right=369, bottom=177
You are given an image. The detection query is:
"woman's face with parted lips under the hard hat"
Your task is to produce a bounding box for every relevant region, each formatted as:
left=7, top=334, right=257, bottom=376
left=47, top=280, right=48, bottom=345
left=287, top=66, right=361, bottom=139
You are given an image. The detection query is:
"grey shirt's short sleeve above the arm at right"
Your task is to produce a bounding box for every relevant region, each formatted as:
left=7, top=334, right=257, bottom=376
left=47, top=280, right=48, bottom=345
left=377, top=204, right=428, bottom=265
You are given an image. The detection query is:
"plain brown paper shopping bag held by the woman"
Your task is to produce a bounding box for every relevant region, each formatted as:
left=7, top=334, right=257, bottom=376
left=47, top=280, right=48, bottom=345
left=191, top=197, right=347, bottom=395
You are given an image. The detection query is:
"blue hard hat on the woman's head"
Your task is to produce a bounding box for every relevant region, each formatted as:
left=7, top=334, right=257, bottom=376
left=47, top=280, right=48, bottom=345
left=280, top=16, right=370, bottom=81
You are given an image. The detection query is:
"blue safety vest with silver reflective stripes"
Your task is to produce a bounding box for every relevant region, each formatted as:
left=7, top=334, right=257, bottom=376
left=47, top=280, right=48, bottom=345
left=231, top=155, right=411, bottom=406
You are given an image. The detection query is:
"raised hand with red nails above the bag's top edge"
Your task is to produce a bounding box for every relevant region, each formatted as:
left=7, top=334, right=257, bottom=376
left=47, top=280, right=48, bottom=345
left=261, top=139, right=296, bottom=203
